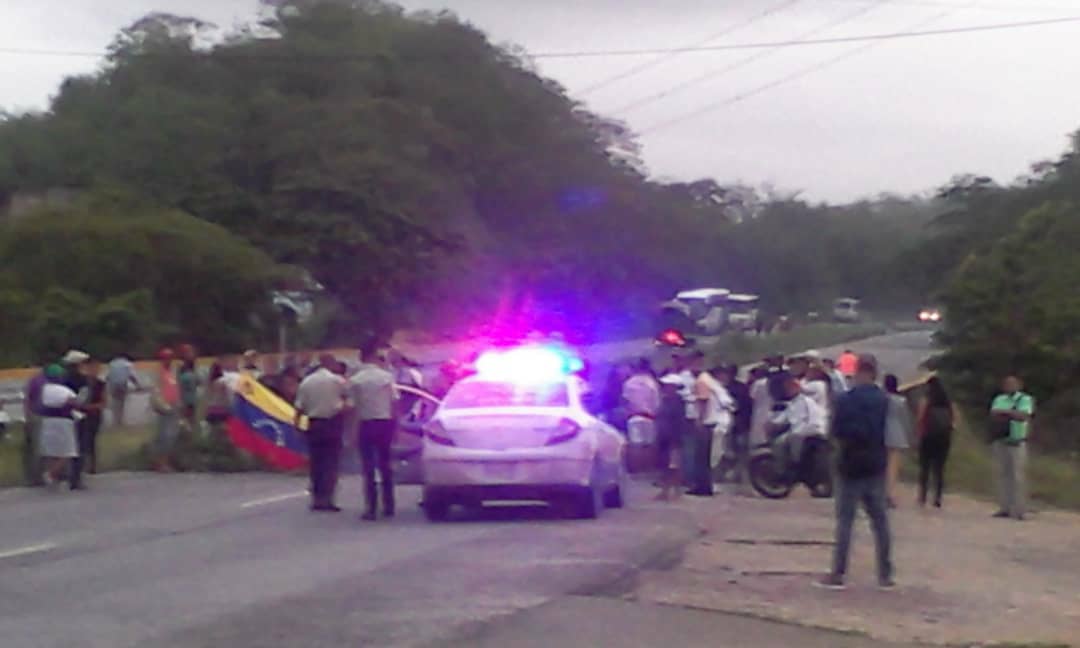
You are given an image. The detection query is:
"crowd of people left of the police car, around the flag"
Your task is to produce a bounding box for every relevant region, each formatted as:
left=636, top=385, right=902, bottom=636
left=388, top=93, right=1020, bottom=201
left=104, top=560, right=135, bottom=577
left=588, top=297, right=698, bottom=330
left=23, top=345, right=425, bottom=503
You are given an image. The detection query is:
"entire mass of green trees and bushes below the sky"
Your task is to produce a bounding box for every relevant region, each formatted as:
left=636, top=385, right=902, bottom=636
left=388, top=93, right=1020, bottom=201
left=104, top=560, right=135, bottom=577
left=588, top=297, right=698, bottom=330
left=0, top=0, right=1080, bottom=481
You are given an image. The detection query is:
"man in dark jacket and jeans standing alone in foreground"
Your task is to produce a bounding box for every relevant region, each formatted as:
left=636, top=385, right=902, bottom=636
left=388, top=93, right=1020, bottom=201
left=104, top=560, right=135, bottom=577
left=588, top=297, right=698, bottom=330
left=815, top=355, right=895, bottom=590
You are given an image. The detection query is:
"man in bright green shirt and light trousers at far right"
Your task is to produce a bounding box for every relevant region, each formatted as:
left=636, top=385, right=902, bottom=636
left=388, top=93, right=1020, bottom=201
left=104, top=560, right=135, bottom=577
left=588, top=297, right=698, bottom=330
left=990, top=376, right=1035, bottom=519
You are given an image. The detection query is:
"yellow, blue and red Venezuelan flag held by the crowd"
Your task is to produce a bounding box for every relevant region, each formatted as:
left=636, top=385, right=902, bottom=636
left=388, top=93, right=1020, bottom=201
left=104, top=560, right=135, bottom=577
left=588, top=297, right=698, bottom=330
left=227, top=374, right=308, bottom=470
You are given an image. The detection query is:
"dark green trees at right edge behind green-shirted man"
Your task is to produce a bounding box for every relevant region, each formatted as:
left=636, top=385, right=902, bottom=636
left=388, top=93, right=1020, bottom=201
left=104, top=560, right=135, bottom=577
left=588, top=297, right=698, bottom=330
left=922, top=137, right=1080, bottom=449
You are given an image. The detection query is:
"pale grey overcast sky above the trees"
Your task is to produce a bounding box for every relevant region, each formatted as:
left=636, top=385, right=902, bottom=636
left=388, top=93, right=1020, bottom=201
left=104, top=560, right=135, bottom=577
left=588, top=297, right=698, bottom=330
left=0, top=0, right=1080, bottom=201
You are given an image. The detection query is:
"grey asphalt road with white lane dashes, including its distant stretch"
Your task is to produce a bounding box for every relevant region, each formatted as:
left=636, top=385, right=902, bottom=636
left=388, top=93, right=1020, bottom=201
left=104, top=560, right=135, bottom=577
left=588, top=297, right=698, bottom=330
left=0, top=333, right=929, bottom=648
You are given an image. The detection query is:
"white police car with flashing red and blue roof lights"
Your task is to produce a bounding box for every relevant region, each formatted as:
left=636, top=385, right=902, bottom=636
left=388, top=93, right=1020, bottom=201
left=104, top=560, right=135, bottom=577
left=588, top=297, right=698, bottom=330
left=422, top=348, right=629, bottom=522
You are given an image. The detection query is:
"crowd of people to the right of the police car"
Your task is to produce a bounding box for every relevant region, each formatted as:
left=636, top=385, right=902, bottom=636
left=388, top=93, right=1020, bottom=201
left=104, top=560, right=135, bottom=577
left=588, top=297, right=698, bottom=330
left=602, top=349, right=1035, bottom=589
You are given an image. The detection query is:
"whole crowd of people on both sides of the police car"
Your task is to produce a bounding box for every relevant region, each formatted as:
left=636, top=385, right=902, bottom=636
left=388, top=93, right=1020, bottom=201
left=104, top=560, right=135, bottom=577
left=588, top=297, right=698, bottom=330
left=12, top=336, right=1035, bottom=565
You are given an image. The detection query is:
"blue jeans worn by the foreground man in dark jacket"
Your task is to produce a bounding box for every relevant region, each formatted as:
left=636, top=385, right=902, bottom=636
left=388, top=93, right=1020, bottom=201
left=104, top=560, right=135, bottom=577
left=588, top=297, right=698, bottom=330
left=833, top=474, right=892, bottom=582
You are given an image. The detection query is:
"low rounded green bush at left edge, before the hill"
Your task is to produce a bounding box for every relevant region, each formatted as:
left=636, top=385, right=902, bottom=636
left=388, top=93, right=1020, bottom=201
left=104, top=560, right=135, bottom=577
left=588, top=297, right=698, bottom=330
left=0, top=192, right=283, bottom=364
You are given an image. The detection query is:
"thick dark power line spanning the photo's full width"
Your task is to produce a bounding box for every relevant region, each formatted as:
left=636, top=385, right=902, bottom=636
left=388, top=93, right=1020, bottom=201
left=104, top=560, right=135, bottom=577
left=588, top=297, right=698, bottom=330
left=0, top=15, right=1080, bottom=60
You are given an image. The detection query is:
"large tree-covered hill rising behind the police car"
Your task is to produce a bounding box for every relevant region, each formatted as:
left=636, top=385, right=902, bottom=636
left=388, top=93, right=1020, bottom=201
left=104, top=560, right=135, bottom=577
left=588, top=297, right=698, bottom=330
left=0, top=0, right=935, bottom=356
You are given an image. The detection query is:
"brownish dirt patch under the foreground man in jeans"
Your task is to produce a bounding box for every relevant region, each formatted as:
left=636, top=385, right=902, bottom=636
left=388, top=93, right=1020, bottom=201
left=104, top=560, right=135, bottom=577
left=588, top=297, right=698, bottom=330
left=635, top=483, right=1080, bottom=646
